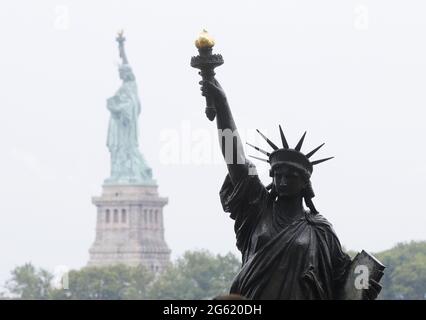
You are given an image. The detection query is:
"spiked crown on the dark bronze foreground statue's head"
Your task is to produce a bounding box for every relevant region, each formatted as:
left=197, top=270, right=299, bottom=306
left=247, top=126, right=334, bottom=176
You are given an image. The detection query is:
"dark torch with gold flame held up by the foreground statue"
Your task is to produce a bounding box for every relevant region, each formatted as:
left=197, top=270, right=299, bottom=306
left=191, top=30, right=224, bottom=121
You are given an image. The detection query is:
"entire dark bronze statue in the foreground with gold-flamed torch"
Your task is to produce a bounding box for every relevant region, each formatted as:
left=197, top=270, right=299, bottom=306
left=191, top=32, right=384, bottom=299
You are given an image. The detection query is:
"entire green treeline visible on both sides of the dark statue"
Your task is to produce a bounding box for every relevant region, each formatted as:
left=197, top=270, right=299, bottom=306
left=6, top=241, right=426, bottom=299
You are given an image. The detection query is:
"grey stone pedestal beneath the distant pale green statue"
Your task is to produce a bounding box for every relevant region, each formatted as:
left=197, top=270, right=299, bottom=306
left=88, top=185, right=170, bottom=272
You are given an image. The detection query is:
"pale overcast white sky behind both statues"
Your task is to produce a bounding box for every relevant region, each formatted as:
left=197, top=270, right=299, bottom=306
left=0, top=0, right=426, bottom=283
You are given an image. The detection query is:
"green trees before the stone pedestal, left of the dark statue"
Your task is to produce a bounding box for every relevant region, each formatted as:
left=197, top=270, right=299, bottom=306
left=0, top=251, right=241, bottom=300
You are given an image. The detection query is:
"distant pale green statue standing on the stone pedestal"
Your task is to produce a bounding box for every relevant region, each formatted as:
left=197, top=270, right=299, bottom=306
left=105, top=31, right=155, bottom=185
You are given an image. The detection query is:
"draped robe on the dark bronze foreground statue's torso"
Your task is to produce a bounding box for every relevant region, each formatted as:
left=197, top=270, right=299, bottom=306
left=220, top=169, right=351, bottom=299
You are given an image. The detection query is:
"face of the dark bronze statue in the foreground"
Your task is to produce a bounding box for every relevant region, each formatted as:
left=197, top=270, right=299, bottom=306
left=273, top=165, right=308, bottom=197
